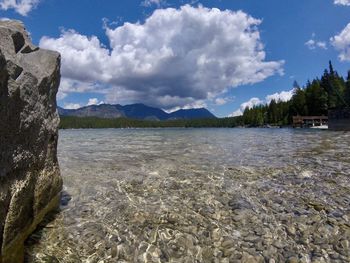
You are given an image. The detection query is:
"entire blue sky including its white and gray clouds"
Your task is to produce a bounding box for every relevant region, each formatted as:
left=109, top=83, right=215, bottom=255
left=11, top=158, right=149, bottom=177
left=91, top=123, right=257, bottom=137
left=0, top=0, right=350, bottom=117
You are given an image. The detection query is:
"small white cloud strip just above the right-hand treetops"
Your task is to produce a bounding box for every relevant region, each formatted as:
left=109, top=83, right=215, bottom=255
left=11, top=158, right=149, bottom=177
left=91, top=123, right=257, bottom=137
left=229, top=89, right=294, bottom=117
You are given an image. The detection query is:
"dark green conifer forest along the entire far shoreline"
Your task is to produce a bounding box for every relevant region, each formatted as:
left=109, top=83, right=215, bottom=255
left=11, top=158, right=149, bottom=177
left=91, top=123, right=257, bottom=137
left=60, top=62, right=350, bottom=129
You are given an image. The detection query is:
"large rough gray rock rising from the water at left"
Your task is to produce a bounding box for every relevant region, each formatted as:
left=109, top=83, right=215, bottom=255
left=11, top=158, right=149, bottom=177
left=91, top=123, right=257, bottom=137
left=0, top=21, right=62, bottom=263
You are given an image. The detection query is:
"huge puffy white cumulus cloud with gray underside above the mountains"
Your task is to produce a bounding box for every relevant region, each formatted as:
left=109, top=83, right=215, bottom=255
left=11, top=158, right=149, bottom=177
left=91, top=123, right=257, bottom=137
left=40, top=5, right=284, bottom=109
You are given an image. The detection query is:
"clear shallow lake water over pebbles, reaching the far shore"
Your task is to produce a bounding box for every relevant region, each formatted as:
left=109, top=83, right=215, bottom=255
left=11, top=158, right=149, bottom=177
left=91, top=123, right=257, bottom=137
left=27, top=129, right=350, bottom=262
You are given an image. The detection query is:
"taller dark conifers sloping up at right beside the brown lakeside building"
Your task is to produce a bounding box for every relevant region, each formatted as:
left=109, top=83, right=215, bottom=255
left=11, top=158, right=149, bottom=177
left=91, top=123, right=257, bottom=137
left=243, top=62, right=350, bottom=126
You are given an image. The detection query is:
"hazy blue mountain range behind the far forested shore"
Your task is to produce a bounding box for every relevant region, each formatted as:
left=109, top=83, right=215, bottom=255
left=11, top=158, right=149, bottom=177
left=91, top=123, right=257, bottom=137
left=58, top=103, right=216, bottom=120
